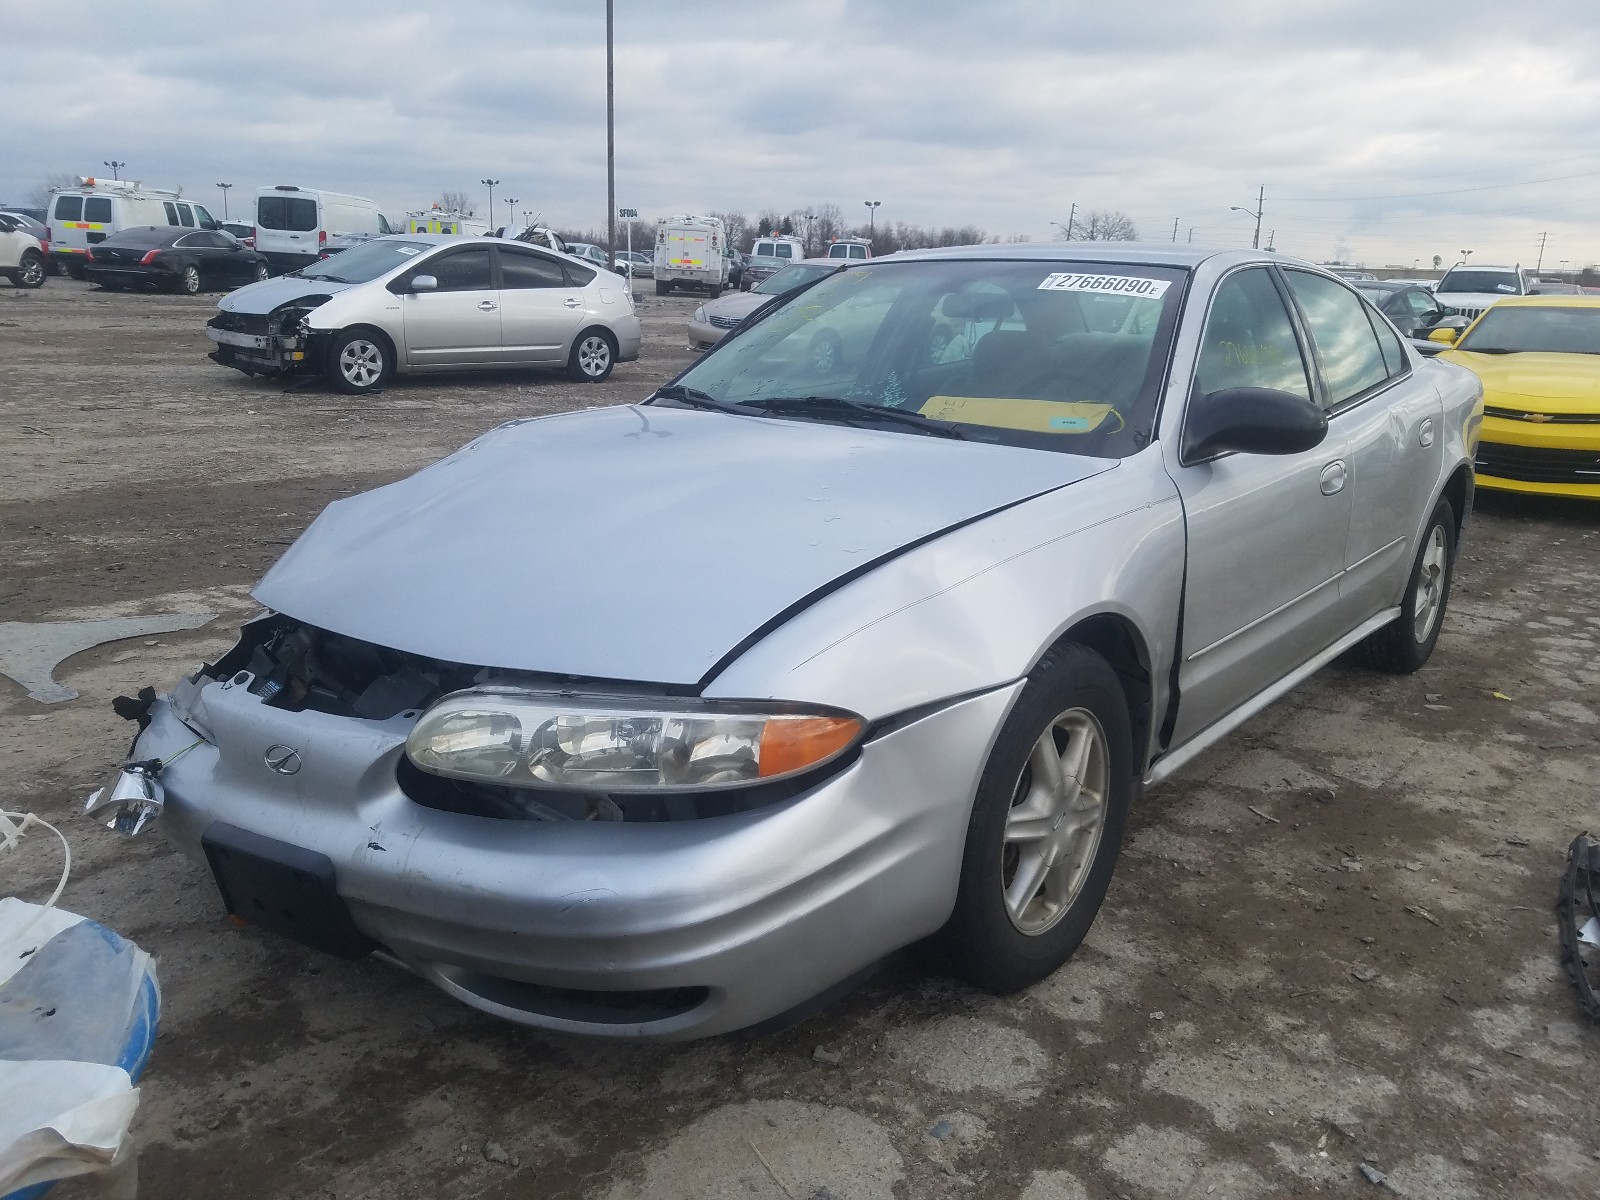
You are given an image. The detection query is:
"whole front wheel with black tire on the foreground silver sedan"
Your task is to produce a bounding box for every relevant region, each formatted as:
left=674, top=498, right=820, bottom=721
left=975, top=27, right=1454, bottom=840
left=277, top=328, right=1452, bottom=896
left=934, top=645, right=1136, bottom=994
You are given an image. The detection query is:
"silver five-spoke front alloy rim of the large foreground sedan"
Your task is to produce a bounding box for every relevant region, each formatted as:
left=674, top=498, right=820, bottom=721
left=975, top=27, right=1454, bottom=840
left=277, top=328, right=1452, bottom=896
left=1000, top=709, right=1110, bottom=936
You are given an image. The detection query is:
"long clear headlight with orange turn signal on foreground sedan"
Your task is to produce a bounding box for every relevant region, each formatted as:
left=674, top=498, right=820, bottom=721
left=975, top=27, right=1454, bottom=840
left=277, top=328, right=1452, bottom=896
left=405, top=688, right=866, bottom=792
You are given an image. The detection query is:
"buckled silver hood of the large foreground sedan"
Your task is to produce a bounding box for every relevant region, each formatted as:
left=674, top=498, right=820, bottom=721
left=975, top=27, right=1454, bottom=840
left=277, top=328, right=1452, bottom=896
left=254, top=405, right=1117, bottom=685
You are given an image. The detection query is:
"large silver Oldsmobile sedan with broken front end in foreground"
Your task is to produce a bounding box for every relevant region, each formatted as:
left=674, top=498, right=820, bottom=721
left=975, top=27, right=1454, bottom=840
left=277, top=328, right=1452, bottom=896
left=106, top=243, right=1482, bottom=1038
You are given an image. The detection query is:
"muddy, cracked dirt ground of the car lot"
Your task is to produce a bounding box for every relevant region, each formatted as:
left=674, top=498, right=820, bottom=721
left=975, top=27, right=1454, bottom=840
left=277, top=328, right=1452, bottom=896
left=0, top=278, right=1600, bottom=1200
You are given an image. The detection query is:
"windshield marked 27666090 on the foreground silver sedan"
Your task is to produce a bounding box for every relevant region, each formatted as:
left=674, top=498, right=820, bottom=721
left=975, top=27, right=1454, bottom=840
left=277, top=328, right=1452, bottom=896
left=678, top=261, right=1184, bottom=458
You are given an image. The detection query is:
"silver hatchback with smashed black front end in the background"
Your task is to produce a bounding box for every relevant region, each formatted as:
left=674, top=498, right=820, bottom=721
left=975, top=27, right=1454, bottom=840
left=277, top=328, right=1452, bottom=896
left=206, top=234, right=640, bottom=394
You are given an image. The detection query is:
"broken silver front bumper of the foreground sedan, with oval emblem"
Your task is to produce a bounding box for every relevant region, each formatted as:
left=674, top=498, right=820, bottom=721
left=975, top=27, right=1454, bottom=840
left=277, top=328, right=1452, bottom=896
left=133, top=624, right=1021, bottom=1040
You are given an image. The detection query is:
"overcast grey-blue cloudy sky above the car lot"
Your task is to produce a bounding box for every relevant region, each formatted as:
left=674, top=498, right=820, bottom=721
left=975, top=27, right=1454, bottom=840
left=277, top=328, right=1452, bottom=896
left=0, top=0, right=1600, bottom=266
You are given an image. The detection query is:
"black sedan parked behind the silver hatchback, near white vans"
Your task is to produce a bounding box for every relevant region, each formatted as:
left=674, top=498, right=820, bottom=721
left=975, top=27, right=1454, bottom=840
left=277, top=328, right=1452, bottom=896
left=83, top=226, right=267, bottom=296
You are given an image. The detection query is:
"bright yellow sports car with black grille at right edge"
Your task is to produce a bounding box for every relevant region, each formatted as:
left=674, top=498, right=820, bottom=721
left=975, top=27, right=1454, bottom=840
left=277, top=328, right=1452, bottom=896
left=1430, top=296, right=1600, bottom=499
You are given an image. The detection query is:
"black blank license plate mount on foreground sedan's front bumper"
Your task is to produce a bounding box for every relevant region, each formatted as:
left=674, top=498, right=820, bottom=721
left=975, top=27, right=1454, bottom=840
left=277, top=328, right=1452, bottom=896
left=200, top=821, right=378, bottom=958
